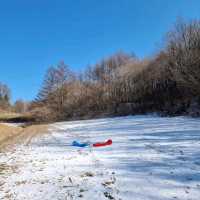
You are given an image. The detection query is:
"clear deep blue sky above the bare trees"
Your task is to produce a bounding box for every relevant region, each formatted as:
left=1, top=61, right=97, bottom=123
left=0, top=0, right=200, bottom=101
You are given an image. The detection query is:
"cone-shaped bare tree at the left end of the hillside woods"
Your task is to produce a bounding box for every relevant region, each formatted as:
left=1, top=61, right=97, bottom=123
left=35, top=62, right=75, bottom=119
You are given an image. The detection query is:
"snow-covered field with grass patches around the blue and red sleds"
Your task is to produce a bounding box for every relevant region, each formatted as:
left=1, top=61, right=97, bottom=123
left=0, top=116, right=200, bottom=200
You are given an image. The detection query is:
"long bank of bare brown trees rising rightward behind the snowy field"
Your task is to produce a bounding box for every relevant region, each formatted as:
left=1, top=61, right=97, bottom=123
left=30, top=20, right=200, bottom=121
